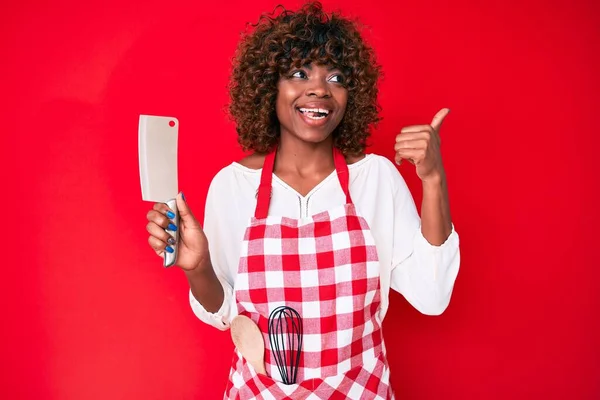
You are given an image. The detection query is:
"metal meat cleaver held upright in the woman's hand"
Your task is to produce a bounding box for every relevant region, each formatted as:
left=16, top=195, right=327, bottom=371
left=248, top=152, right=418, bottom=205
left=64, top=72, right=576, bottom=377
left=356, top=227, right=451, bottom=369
left=138, top=115, right=179, bottom=267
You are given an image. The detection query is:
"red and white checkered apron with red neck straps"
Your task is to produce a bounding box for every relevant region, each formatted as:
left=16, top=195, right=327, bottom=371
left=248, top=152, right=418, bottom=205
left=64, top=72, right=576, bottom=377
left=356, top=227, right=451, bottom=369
left=224, top=149, right=393, bottom=399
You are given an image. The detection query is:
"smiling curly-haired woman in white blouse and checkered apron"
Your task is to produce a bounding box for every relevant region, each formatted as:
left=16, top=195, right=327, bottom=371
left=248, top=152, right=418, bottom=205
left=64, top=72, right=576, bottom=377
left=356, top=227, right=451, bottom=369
left=148, top=3, right=460, bottom=399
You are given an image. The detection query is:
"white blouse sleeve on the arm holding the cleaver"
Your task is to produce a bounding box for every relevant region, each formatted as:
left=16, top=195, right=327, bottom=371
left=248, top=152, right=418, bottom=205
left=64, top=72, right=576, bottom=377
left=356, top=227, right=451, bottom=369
left=189, top=172, right=234, bottom=331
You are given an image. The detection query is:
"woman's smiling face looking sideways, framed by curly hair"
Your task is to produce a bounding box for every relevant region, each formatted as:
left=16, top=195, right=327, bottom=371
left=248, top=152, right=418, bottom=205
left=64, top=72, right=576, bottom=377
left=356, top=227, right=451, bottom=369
left=275, top=63, right=348, bottom=143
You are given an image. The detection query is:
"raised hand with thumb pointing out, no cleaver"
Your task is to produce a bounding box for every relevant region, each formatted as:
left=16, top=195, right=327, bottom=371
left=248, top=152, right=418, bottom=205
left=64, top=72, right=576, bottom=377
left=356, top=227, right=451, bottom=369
left=394, top=108, right=450, bottom=182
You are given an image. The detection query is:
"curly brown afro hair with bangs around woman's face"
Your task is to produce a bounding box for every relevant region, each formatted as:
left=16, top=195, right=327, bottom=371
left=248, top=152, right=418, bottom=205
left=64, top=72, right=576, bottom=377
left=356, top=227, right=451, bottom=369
left=229, top=2, right=381, bottom=155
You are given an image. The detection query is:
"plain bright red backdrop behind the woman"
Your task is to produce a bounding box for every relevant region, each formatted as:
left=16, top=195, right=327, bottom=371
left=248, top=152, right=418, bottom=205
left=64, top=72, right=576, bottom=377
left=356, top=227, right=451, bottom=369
left=0, top=0, right=600, bottom=400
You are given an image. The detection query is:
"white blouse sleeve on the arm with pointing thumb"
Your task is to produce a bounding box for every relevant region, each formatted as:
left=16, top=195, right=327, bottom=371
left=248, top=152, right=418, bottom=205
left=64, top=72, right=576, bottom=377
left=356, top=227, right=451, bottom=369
left=391, top=167, right=460, bottom=315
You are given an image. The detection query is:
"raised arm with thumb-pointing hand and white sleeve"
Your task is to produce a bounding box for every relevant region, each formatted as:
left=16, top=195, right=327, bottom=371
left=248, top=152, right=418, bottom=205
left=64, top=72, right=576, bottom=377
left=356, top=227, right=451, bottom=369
left=392, top=109, right=460, bottom=315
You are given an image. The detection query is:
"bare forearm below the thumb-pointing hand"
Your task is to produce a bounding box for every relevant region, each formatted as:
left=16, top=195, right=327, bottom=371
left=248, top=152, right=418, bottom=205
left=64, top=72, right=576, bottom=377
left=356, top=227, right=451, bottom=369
left=421, top=174, right=452, bottom=246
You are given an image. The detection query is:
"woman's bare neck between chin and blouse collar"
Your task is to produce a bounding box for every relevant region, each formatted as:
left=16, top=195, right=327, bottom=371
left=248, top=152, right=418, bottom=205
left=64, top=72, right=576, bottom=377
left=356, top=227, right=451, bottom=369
left=275, top=135, right=335, bottom=175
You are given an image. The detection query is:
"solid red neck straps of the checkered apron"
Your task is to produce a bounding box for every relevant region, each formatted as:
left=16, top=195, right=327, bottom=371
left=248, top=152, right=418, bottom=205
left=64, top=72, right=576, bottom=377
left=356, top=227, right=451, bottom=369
left=254, top=147, right=352, bottom=219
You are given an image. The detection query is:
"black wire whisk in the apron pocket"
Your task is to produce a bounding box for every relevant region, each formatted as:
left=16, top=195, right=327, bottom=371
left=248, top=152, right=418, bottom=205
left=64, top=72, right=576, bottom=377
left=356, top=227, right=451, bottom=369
left=268, top=306, right=302, bottom=385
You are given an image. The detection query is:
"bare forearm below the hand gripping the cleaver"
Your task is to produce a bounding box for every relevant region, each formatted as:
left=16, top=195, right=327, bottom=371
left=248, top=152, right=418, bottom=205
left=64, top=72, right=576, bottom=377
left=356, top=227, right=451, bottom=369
left=185, top=257, right=225, bottom=313
